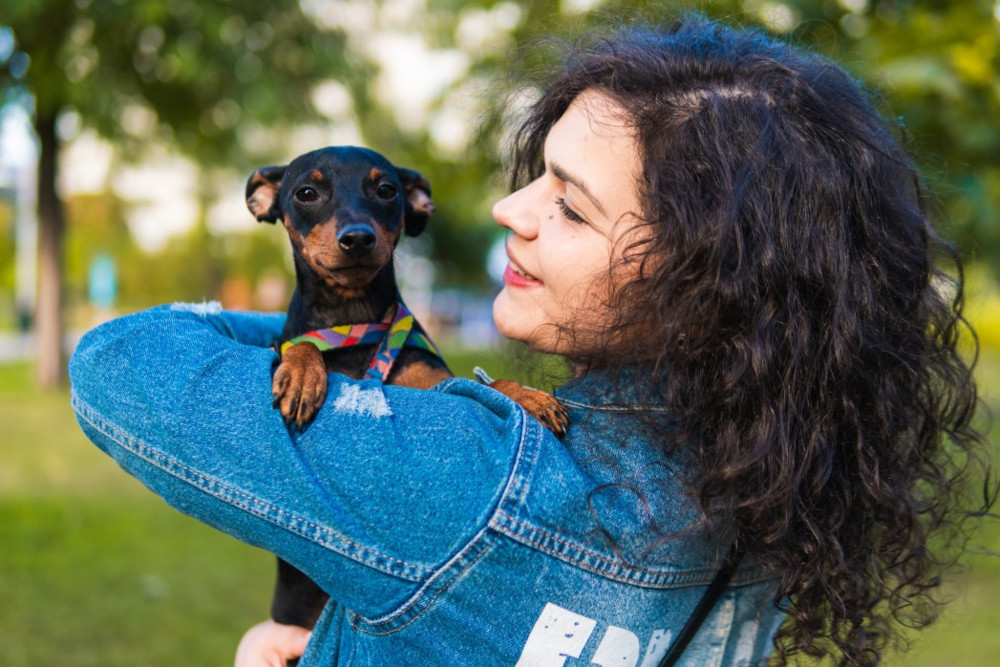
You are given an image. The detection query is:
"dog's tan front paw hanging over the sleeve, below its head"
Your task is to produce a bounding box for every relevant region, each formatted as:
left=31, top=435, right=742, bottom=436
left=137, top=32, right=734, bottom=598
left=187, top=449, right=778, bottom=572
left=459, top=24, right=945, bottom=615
left=271, top=343, right=326, bottom=431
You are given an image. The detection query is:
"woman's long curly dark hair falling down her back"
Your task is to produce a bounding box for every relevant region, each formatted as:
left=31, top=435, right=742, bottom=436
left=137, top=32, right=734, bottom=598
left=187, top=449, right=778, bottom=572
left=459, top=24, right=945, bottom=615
left=511, top=15, right=996, bottom=665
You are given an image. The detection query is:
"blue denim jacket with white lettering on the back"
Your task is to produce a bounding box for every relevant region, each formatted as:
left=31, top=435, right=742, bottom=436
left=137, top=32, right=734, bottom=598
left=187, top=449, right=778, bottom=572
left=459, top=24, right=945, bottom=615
left=70, top=304, right=782, bottom=667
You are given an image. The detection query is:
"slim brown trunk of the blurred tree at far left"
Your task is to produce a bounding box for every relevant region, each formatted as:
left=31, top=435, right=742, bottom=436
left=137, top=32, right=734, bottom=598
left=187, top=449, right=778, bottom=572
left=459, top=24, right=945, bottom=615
left=35, top=113, right=66, bottom=388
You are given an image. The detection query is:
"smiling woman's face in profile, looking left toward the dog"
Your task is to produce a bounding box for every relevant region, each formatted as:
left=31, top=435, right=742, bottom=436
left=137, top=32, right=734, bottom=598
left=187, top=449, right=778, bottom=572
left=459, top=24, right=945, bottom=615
left=493, top=90, right=641, bottom=356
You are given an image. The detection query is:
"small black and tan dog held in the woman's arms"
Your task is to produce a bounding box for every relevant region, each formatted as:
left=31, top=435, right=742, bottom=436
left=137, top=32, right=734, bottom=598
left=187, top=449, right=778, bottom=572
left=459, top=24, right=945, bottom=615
left=246, top=146, right=567, bottom=628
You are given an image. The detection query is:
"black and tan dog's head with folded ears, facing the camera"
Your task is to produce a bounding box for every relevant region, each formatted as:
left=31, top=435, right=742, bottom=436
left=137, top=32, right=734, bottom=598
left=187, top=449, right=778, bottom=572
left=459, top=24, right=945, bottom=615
left=246, top=146, right=434, bottom=288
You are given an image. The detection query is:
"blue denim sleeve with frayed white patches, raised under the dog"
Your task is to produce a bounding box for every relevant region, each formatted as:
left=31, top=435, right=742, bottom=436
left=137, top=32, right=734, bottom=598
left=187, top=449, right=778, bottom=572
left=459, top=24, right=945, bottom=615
left=70, top=306, right=523, bottom=616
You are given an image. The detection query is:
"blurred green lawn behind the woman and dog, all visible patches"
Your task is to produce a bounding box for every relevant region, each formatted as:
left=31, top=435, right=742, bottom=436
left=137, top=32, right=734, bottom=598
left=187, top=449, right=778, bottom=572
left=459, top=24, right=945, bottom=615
left=0, top=353, right=1000, bottom=667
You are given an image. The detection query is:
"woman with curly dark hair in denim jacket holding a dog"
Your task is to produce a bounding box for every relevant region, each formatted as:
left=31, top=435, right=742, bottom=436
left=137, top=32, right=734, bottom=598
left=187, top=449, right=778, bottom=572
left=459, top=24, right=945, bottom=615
left=71, top=18, right=989, bottom=665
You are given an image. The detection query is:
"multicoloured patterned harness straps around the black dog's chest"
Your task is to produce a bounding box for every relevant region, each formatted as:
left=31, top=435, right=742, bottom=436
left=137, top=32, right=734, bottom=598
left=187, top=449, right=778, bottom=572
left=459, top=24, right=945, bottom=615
left=281, top=297, right=444, bottom=382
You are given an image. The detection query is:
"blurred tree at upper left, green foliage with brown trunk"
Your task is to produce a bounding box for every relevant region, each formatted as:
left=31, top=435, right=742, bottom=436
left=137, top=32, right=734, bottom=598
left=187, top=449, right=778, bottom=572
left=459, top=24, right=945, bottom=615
left=0, top=0, right=344, bottom=386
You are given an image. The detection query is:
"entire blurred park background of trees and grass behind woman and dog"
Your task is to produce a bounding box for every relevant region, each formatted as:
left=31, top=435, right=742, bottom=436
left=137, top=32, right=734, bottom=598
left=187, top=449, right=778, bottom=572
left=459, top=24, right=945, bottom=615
left=0, top=0, right=1000, bottom=666
